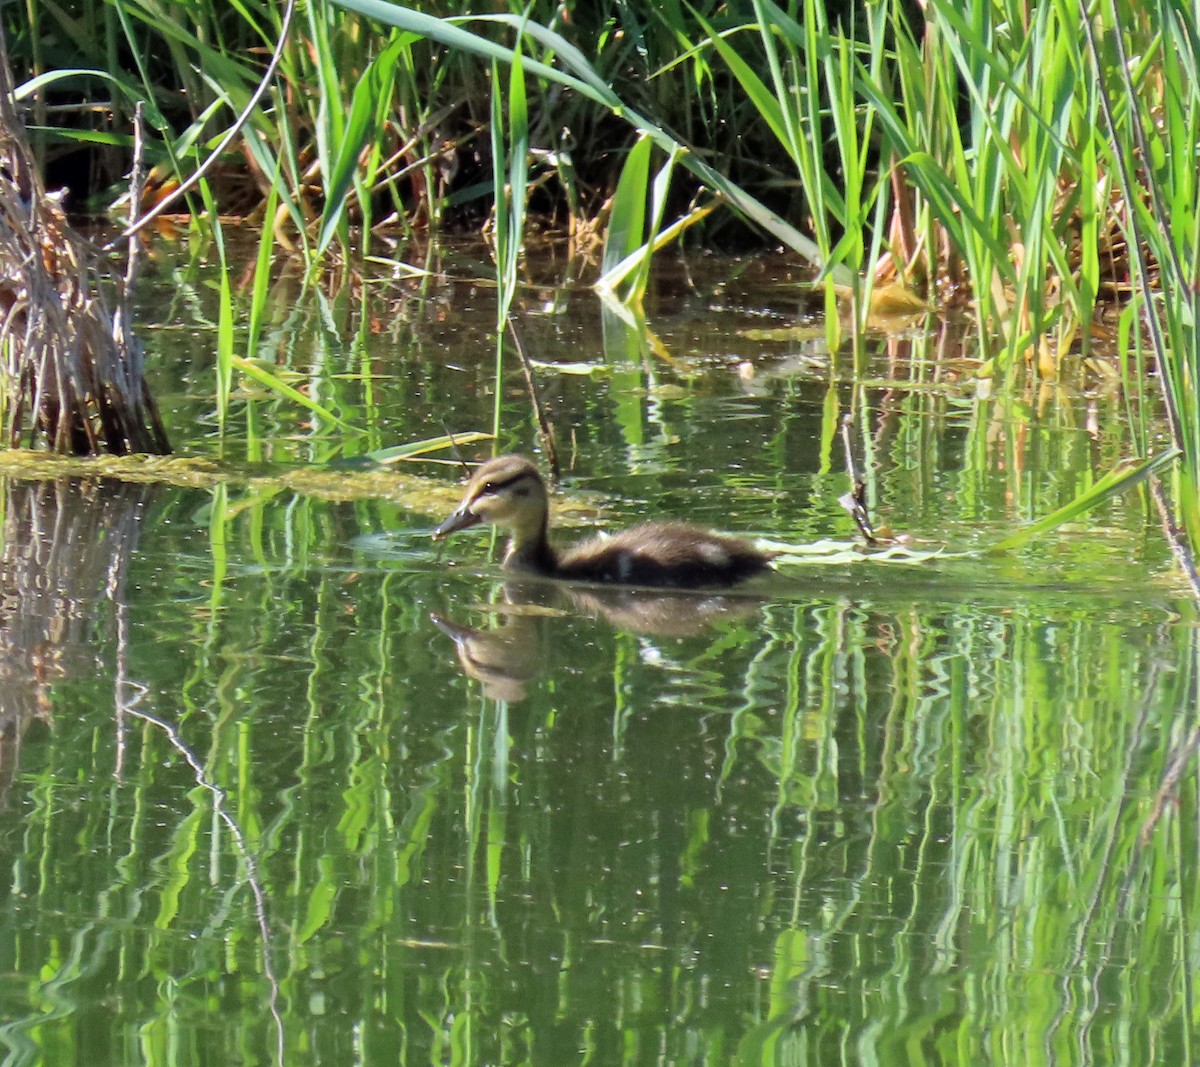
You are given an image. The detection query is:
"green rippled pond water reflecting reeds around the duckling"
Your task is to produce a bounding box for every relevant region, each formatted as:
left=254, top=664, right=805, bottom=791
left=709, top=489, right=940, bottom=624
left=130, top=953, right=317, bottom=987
left=0, top=246, right=1200, bottom=1067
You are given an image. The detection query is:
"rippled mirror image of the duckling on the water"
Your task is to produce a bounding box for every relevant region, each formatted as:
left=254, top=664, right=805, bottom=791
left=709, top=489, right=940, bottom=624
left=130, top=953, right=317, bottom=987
left=430, top=580, right=766, bottom=703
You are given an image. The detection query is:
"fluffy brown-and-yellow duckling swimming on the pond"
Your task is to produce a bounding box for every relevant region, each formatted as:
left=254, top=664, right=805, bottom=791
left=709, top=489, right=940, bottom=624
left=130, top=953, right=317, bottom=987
left=433, top=455, right=774, bottom=588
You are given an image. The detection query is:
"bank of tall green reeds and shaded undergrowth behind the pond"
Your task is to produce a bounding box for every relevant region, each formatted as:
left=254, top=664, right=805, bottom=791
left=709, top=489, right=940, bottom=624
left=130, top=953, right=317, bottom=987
left=4, top=0, right=1200, bottom=573
